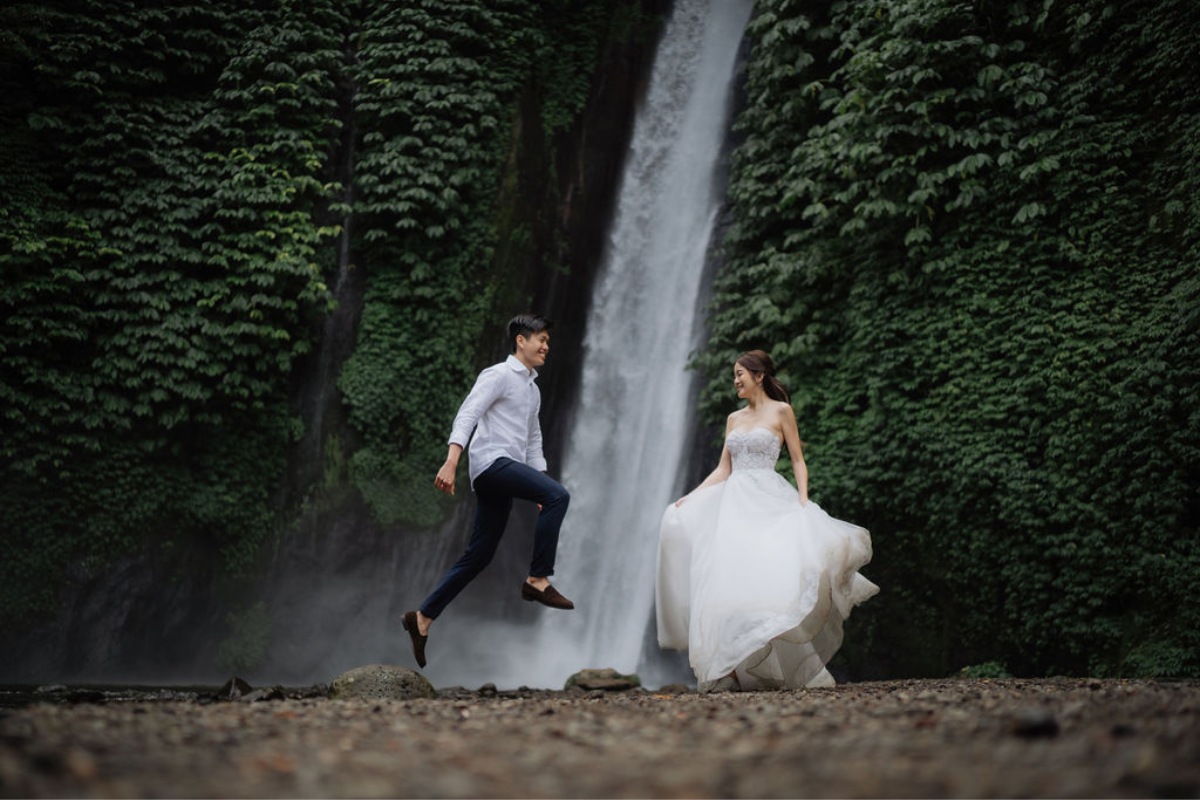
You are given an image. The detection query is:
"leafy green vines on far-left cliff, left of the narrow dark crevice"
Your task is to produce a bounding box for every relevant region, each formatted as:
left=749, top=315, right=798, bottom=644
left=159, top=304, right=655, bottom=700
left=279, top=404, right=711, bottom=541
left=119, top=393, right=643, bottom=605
left=0, top=2, right=341, bottom=615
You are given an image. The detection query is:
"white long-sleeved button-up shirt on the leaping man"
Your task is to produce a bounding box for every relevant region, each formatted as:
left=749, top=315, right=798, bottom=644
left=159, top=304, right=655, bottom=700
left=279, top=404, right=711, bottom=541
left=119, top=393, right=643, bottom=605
left=449, top=355, right=546, bottom=488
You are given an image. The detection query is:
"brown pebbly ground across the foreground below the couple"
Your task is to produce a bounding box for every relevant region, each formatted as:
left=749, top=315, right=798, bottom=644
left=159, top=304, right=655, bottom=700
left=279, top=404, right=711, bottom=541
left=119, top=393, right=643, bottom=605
left=0, top=679, right=1200, bottom=798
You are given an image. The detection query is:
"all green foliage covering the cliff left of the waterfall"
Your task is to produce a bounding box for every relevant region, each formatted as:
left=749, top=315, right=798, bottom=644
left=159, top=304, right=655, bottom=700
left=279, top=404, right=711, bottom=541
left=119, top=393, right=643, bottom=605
left=0, top=0, right=637, bottom=623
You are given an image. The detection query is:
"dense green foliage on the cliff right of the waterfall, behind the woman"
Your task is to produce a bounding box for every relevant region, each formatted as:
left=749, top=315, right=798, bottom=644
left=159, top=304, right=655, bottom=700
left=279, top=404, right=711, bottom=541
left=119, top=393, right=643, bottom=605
left=698, top=0, right=1200, bottom=676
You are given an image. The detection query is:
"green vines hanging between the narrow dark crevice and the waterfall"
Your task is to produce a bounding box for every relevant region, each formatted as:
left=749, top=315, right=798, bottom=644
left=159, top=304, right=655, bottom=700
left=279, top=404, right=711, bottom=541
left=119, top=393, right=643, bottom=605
left=338, top=0, right=628, bottom=525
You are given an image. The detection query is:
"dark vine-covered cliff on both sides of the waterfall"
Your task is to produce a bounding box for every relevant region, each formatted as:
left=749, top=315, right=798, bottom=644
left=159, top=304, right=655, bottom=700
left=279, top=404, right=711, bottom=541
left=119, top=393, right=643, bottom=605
left=0, top=0, right=1200, bottom=676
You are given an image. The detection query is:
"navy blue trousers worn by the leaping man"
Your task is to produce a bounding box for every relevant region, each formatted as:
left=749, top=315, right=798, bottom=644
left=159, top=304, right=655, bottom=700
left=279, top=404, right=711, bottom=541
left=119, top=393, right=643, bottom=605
left=421, top=458, right=571, bottom=619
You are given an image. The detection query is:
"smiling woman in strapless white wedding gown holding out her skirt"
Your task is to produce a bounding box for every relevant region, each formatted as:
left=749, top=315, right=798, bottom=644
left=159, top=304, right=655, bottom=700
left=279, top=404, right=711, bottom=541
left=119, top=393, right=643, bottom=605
left=656, top=350, right=878, bottom=692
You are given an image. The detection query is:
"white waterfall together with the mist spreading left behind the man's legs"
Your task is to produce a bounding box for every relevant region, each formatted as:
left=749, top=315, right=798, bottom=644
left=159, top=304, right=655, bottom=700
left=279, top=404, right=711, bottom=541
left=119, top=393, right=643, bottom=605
left=268, top=0, right=752, bottom=688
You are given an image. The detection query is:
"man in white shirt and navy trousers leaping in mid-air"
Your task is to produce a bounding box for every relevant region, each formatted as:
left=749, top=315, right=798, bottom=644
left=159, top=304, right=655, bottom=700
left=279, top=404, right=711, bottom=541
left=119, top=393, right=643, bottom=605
left=403, top=314, right=575, bottom=667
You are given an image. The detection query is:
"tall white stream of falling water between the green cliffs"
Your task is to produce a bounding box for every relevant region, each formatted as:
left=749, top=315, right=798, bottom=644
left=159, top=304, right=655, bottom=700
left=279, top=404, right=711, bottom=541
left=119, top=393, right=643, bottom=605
left=415, top=0, right=752, bottom=687
